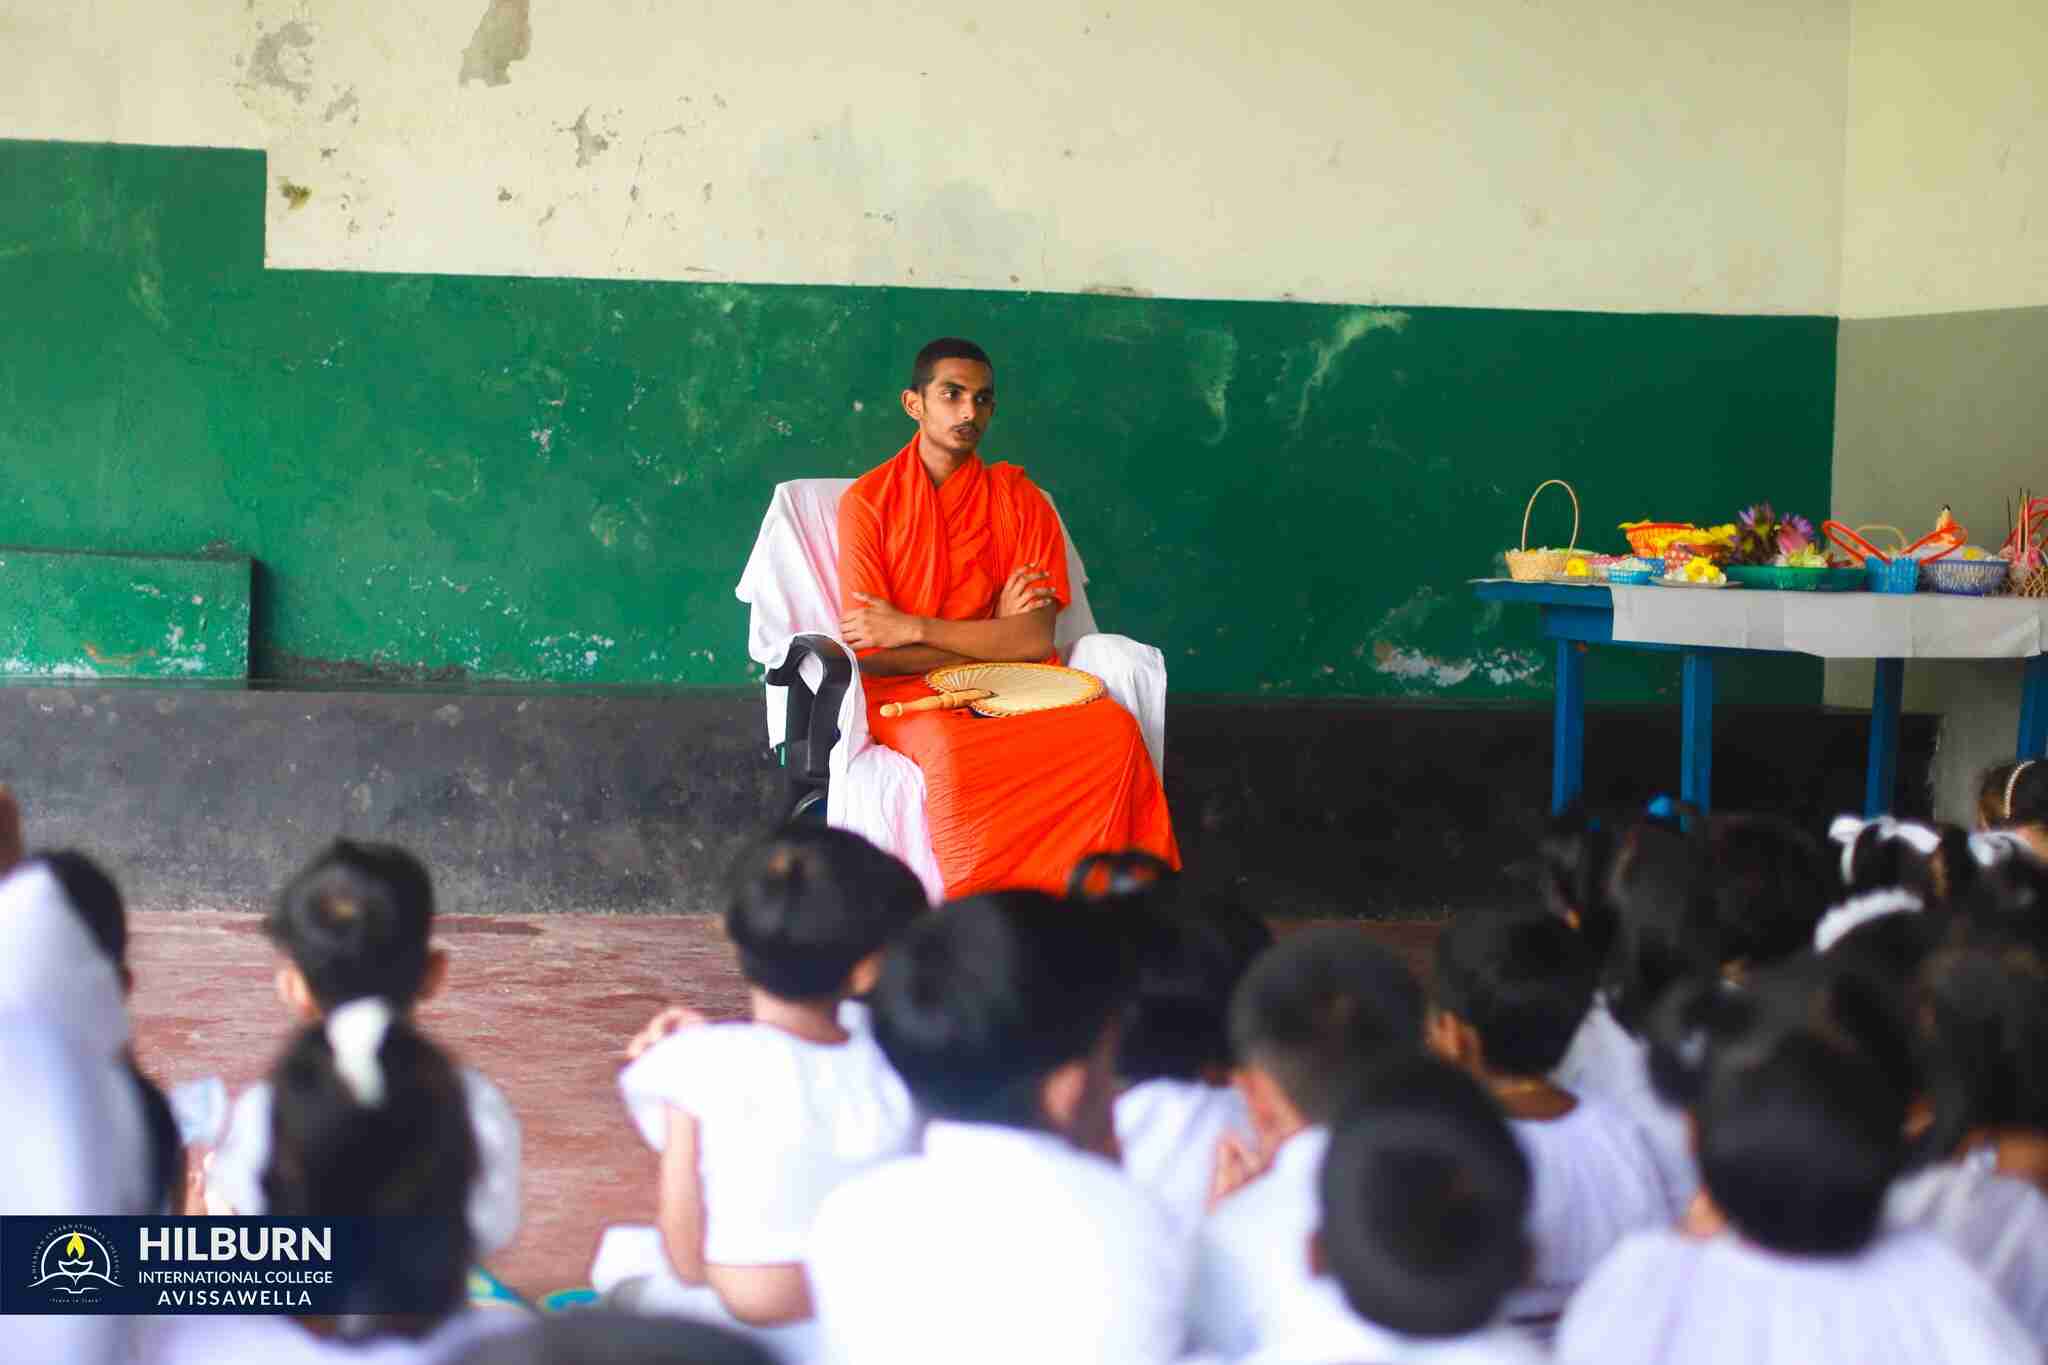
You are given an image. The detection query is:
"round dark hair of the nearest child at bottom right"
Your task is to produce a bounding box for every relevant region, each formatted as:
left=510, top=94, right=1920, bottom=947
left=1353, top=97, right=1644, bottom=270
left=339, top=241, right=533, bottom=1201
left=1694, top=1029, right=1907, bottom=1257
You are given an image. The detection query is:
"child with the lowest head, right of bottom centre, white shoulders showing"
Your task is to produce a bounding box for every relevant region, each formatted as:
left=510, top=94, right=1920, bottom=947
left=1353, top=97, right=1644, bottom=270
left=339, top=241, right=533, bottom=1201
left=1243, top=1056, right=1542, bottom=1365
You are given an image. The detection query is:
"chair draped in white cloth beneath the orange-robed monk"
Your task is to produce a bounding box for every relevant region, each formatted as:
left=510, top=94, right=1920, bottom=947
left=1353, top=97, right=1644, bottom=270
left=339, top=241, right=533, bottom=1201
left=733, top=479, right=1165, bottom=900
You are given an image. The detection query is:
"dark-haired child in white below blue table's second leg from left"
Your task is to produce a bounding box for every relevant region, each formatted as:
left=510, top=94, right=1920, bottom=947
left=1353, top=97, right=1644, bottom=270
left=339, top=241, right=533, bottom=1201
left=1550, top=823, right=1729, bottom=1207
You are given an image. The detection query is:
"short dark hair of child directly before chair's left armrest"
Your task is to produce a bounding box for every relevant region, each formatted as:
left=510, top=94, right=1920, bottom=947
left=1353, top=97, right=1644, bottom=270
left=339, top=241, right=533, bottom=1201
left=725, top=825, right=928, bottom=1001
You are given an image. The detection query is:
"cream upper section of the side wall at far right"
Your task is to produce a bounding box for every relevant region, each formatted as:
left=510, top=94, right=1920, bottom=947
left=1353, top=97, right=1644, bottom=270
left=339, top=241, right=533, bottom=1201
left=1841, top=0, right=2048, bottom=317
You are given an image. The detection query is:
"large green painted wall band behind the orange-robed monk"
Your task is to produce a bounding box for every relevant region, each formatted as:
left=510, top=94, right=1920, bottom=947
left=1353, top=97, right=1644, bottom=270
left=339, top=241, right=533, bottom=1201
left=0, top=141, right=1835, bottom=702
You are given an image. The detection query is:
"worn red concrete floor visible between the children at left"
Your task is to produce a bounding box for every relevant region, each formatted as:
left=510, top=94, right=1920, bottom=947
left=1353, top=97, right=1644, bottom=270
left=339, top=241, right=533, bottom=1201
left=129, top=911, right=1438, bottom=1295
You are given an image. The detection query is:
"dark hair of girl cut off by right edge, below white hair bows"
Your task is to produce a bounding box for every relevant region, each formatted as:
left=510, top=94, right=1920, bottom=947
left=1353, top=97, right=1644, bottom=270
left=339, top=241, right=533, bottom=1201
left=1913, top=943, right=2048, bottom=1160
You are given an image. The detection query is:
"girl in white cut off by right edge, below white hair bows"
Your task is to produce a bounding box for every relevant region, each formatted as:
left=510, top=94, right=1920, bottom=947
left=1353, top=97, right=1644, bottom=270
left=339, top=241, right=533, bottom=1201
left=1886, top=945, right=2048, bottom=1345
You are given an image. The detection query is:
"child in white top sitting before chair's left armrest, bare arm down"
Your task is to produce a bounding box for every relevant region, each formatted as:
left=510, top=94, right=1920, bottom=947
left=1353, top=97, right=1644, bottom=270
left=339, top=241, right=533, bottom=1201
left=610, top=827, right=926, bottom=1357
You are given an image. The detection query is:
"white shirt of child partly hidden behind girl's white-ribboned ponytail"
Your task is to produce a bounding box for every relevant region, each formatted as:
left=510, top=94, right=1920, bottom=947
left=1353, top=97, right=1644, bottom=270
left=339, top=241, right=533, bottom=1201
left=207, top=1066, right=520, bottom=1261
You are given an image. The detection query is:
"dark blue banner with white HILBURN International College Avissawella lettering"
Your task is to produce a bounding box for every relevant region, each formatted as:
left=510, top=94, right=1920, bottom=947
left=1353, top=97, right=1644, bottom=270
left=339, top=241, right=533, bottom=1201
left=0, top=1218, right=463, bottom=1316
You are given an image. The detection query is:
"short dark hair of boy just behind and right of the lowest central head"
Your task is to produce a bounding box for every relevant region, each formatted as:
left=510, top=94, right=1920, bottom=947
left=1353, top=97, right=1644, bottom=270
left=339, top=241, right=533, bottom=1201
left=1430, top=911, right=1599, bottom=1076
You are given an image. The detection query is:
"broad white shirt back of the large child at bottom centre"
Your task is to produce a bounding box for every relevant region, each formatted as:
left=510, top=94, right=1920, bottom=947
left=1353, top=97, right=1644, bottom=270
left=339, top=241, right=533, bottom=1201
left=809, top=1121, right=1188, bottom=1365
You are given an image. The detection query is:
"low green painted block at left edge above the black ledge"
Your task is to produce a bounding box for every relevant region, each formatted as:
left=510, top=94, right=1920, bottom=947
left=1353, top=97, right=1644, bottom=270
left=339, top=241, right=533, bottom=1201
left=0, top=546, right=250, bottom=679
